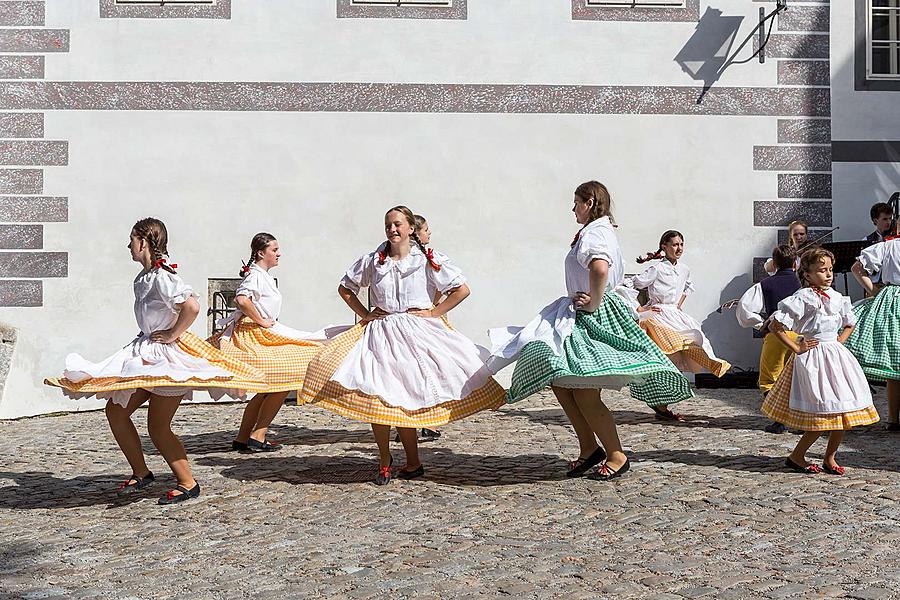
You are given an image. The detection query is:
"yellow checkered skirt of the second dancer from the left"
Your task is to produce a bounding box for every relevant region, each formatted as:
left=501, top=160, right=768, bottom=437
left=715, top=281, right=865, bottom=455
left=209, top=318, right=322, bottom=393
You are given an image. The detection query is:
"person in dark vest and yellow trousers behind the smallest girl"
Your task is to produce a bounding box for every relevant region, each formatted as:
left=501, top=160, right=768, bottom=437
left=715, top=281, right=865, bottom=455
left=736, top=242, right=802, bottom=433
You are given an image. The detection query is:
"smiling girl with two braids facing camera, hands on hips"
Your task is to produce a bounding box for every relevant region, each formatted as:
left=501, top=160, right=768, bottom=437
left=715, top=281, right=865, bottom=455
left=299, top=206, right=504, bottom=485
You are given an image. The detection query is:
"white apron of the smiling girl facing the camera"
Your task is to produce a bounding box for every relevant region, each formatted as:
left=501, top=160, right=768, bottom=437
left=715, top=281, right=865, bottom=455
left=331, top=313, right=491, bottom=410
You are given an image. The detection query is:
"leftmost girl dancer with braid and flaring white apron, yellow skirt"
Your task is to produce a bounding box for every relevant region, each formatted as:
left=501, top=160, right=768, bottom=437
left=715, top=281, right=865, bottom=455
left=45, top=218, right=265, bottom=504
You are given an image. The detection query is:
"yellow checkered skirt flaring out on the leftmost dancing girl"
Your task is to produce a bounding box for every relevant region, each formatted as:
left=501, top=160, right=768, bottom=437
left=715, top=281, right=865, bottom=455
left=44, top=331, right=266, bottom=398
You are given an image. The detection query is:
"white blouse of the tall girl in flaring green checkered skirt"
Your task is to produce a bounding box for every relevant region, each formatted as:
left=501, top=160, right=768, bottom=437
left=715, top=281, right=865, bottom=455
left=566, top=217, right=625, bottom=298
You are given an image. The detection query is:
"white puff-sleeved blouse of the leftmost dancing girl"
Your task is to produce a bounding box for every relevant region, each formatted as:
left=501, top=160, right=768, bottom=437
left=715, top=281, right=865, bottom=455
left=134, top=269, right=197, bottom=335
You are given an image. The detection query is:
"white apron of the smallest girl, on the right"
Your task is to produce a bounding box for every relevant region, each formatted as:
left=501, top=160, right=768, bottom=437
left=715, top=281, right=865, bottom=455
left=790, top=339, right=872, bottom=414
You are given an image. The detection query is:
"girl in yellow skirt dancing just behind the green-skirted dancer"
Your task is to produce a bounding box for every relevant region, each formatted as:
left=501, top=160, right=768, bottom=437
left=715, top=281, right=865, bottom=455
left=625, top=230, right=731, bottom=421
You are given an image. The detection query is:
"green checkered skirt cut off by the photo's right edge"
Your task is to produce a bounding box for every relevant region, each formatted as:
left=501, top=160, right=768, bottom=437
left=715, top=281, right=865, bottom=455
left=845, top=285, right=900, bottom=381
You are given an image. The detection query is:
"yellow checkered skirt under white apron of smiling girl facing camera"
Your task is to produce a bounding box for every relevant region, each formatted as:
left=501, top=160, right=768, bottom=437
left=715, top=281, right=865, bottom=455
left=297, top=321, right=506, bottom=428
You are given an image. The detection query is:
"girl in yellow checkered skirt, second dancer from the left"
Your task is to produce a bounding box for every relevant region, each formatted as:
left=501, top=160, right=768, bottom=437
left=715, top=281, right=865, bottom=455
left=210, top=232, right=342, bottom=452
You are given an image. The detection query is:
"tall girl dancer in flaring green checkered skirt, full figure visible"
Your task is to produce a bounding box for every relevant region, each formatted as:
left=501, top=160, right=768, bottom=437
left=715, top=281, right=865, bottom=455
left=488, top=181, right=693, bottom=481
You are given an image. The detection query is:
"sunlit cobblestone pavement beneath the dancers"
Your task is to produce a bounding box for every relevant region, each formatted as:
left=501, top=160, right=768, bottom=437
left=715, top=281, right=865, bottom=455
left=0, top=388, right=900, bottom=599
